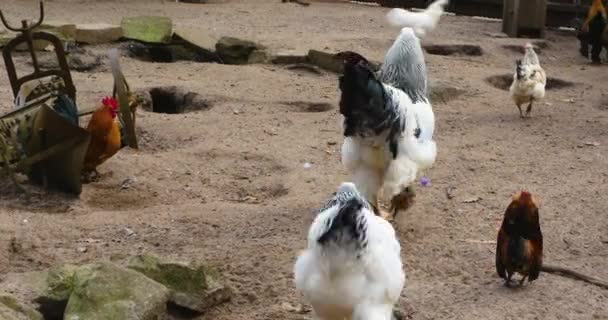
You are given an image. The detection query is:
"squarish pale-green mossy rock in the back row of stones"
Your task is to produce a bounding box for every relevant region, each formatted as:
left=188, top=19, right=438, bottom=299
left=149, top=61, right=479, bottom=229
left=121, top=16, right=173, bottom=43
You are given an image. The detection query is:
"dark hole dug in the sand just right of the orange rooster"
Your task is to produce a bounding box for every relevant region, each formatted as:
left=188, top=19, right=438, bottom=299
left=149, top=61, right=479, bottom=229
left=143, top=87, right=211, bottom=114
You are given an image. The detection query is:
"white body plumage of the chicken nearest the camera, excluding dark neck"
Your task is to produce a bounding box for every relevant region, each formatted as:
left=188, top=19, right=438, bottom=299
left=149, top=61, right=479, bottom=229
left=294, top=184, right=405, bottom=320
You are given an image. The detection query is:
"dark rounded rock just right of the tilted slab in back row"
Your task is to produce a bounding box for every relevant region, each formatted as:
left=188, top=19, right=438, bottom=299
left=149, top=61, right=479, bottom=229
left=215, top=37, right=267, bottom=64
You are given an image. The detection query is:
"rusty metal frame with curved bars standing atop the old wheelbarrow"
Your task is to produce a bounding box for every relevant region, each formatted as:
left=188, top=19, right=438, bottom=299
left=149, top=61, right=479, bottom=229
left=0, top=1, right=76, bottom=102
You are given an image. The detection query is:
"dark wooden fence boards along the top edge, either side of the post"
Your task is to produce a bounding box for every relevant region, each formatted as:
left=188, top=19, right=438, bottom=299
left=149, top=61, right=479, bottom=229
left=363, top=0, right=592, bottom=27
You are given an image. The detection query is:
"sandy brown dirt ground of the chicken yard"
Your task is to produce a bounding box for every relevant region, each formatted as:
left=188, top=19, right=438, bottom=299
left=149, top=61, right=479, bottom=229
left=0, top=0, right=608, bottom=320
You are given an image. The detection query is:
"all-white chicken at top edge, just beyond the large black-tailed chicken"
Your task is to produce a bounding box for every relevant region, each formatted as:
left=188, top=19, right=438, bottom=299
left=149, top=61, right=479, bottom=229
left=386, top=0, right=448, bottom=38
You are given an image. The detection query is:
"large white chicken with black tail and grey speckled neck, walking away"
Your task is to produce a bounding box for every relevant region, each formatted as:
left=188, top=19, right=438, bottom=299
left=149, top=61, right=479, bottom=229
left=338, top=28, right=437, bottom=217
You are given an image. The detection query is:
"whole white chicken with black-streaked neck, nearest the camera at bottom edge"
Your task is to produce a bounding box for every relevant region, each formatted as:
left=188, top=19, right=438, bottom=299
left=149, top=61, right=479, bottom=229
left=294, top=182, right=405, bottom=320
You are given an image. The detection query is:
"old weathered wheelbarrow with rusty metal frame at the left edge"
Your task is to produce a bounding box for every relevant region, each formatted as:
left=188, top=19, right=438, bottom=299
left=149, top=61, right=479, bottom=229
left=0, top=2, right=137, bottom=194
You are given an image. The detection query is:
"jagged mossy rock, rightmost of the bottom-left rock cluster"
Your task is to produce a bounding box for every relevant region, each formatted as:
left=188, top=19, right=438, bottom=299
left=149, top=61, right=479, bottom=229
left=128, top=255, right=232, bottom=313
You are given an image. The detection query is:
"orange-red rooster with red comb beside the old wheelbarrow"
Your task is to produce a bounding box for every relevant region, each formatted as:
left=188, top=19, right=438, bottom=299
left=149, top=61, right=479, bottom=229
left=83, top=97, right=121, bottom=180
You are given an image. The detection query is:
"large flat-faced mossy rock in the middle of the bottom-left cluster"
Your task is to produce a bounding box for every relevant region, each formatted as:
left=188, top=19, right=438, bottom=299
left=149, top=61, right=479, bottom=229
left=64, top=262, right=169, bottom=320
